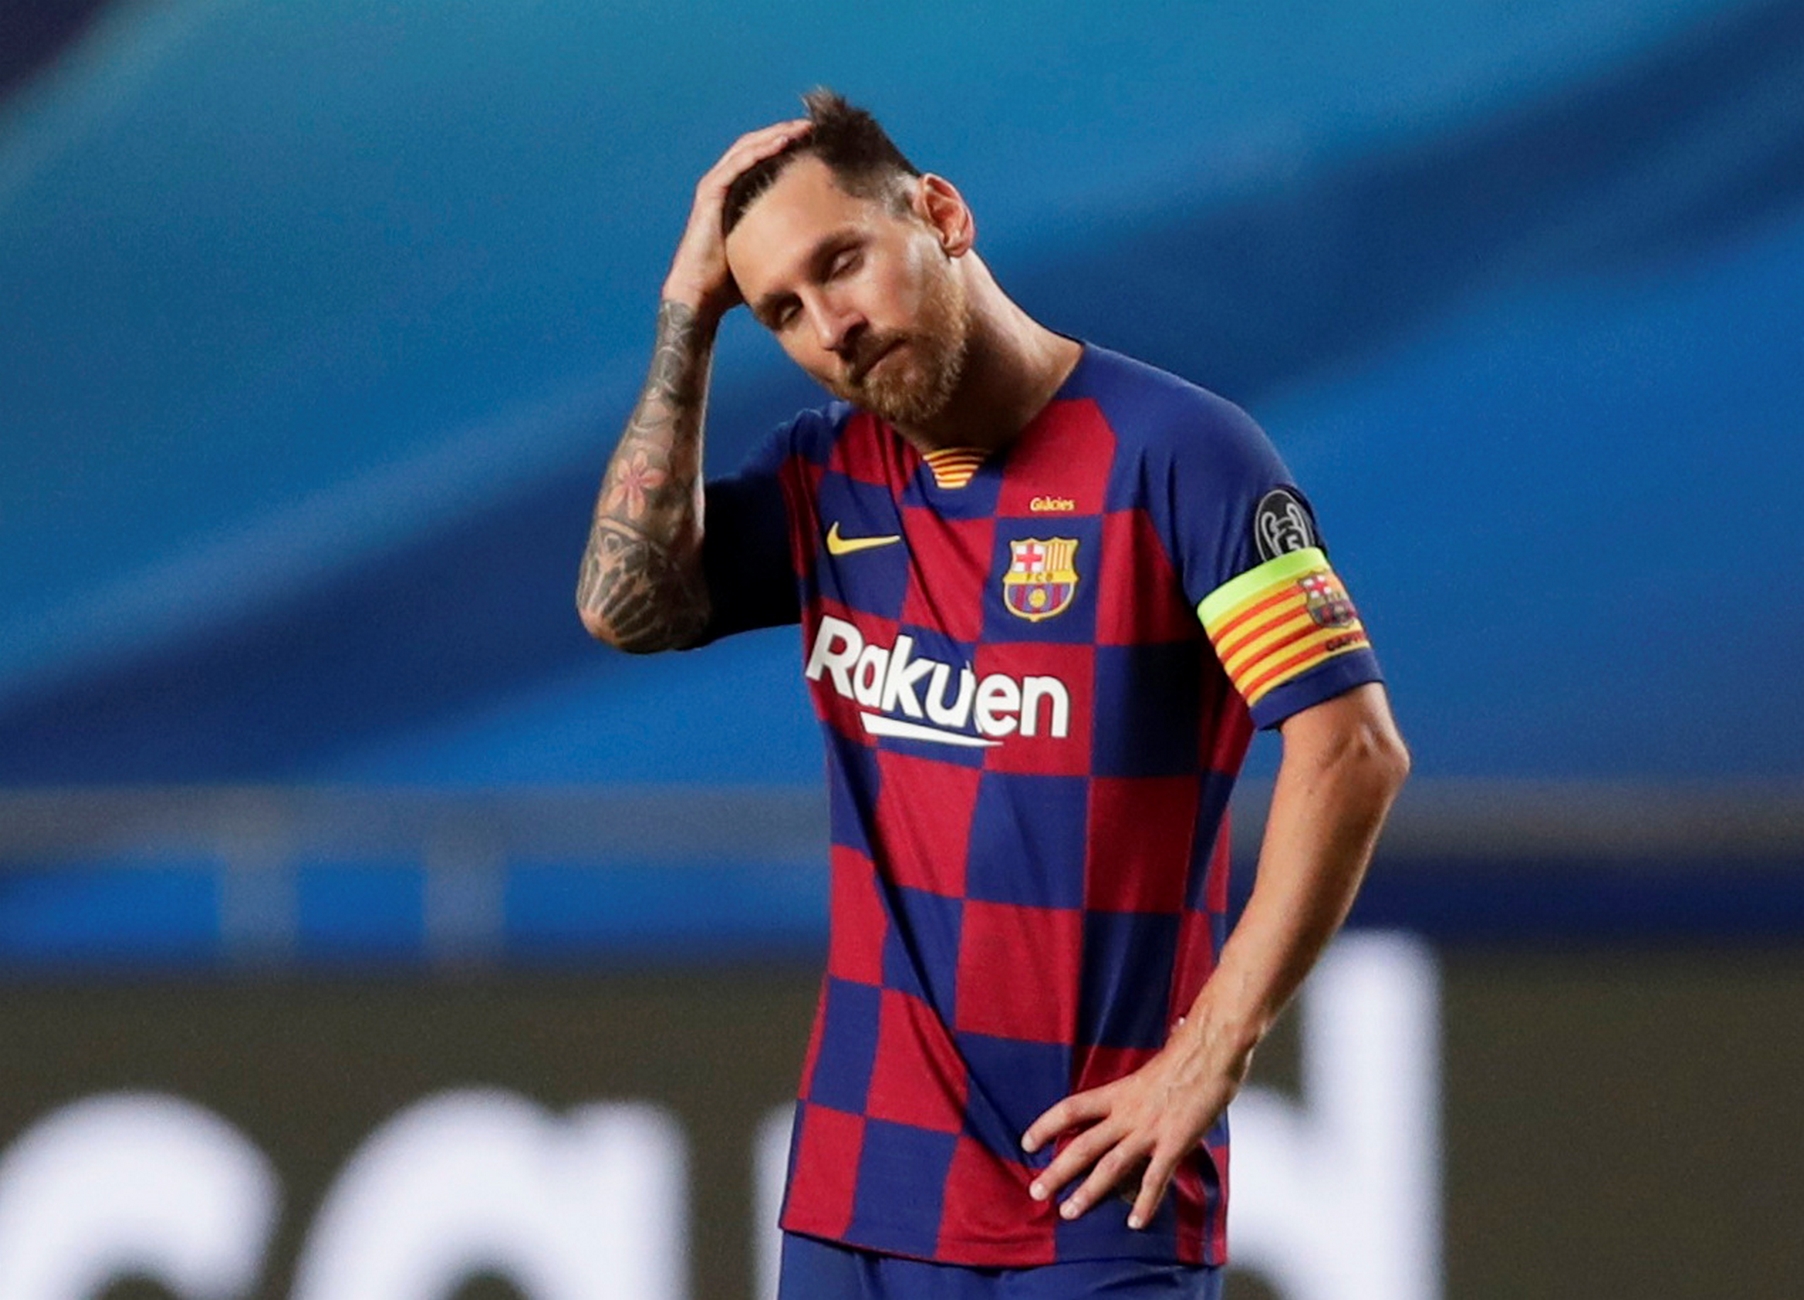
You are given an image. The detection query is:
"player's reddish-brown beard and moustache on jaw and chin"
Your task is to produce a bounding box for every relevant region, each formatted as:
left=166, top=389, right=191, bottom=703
left=828, top=257, right=971, bottom=427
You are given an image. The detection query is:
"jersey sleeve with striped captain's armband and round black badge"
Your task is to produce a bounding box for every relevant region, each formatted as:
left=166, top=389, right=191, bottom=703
left=1169, top=398, right=1382, bottom=727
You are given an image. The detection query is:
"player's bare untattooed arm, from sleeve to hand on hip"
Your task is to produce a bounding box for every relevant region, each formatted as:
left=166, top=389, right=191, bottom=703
left=1021, top=685, right=1409, bottom=1228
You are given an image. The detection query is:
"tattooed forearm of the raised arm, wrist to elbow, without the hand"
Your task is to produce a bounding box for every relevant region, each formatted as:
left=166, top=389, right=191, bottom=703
left=575, top=303, right=713, bottom=653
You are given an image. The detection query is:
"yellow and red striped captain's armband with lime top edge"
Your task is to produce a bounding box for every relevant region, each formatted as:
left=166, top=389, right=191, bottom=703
left=1196, top=546, right=1371, bottom=705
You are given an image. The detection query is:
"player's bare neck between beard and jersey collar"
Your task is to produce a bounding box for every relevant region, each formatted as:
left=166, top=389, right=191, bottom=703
left=897, top=252, right=1082, bottom=451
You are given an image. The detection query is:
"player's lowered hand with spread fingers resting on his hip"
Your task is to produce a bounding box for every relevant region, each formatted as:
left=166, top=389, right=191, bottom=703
left=1021, top=1021, right=1252, bottom=1230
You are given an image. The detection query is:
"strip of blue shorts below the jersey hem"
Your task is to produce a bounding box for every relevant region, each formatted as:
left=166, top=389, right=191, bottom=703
left=778, top=1231, right=1221, bottom=1300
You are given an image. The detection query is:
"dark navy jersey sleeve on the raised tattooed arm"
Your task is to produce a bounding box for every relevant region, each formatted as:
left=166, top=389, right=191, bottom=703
left=696, top=422, right=801, bottom=645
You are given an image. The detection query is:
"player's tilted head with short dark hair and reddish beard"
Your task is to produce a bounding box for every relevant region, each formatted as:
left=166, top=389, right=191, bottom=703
left=722, top=90, right=972, bottom=426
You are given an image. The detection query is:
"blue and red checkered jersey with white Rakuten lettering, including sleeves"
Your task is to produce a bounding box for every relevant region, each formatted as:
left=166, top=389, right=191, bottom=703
left=704, top=338, right=1378, bottom=1266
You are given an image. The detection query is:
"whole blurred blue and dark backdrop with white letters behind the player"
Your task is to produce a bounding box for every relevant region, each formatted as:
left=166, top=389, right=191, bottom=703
left=0, top=0, right=1804, bottom=1300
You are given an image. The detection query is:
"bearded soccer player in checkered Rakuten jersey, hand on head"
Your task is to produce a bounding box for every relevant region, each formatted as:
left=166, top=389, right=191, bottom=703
left=577, top=92, right=1409, bottom=1300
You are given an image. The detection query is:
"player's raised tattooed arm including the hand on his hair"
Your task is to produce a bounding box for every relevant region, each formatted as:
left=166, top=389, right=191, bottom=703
left=575, top=121, right=808, bottom=655
